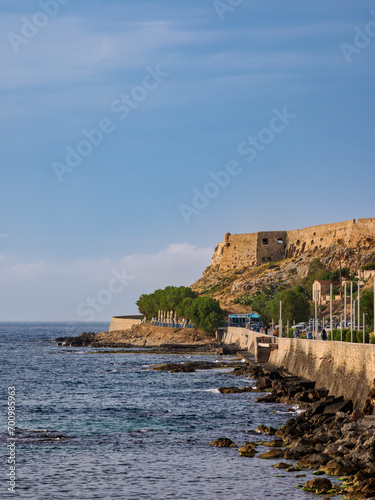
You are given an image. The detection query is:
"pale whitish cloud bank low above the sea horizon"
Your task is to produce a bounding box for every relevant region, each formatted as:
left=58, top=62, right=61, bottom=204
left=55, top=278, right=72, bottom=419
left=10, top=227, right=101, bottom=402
left=0, top=243, right=213, bottom=321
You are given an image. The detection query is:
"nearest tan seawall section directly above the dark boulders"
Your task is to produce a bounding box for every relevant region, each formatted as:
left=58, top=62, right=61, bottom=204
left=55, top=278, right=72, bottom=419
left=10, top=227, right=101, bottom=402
left=269, top=338, right=375, bottom=408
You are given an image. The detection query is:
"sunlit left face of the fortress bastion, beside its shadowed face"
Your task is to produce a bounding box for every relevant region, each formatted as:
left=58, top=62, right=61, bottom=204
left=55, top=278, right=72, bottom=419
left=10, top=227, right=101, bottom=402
left=220, top=233, right=258, bottom=271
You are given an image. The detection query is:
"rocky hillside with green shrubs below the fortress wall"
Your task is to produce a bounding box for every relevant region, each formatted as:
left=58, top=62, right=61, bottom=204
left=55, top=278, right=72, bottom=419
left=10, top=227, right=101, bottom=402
left=191, top=244, right=375, bottom=328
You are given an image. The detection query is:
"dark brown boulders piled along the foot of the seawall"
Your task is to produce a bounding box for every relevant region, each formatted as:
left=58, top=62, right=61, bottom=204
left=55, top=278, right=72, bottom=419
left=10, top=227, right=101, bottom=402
left=210, top=364, right=375, bottom=500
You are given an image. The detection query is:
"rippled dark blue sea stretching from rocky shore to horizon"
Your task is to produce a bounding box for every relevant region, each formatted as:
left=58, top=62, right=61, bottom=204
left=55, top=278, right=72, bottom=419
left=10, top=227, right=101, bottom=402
left=0, top=323, right=310, bottom=500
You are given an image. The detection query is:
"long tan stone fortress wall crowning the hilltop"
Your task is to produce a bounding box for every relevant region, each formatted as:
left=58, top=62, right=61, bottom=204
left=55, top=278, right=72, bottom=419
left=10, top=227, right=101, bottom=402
left=210, top=218, right=375, bottom=271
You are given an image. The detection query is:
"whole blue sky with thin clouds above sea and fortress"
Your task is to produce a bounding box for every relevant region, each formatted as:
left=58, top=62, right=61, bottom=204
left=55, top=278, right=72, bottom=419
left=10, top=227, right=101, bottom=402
left=0, top=0, right=375, bottom=320
